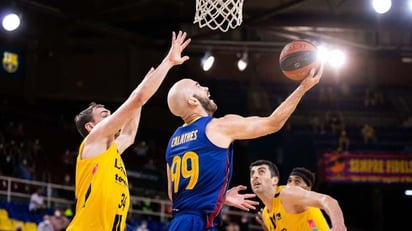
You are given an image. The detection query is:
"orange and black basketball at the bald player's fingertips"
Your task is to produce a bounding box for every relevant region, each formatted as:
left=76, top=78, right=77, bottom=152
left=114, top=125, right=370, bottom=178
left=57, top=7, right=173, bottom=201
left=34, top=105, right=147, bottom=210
left=279, top=40, right=321, bottom=81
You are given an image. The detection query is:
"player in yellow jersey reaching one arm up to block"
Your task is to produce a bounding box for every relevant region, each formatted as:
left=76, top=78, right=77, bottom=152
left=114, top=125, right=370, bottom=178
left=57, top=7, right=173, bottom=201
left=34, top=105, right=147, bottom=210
left=67, top=31, right=190, bottom=231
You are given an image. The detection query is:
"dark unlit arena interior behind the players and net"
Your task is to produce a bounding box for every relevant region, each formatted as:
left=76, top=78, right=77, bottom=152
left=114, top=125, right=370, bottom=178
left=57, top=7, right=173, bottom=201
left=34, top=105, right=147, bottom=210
left=0, top=0, right=412, bottom=230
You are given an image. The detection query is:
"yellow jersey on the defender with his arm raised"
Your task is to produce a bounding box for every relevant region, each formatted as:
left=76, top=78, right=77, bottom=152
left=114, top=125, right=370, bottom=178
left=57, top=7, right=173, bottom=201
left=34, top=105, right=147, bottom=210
left=66, top=139, right=130, bottom=231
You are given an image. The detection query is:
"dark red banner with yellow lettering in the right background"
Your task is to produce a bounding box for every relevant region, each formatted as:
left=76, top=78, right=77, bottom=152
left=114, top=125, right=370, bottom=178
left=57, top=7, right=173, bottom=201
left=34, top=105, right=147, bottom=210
left=323, top=153, right=412, bottom=183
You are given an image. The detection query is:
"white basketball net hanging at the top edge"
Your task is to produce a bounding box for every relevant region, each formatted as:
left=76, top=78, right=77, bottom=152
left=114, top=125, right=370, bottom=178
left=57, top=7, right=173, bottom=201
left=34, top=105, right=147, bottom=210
left=193, top=0, right=243, bottom=32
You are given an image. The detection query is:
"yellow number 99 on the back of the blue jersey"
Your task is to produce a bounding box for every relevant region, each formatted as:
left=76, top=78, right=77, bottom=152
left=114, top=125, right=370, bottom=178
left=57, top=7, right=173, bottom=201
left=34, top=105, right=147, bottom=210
left=170, top=152, right=199, bottom=193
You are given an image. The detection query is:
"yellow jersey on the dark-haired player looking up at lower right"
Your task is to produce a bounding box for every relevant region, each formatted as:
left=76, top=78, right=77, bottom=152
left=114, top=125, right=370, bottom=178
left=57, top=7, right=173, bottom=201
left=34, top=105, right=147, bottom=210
left=262, top=186, right=329, bottom=231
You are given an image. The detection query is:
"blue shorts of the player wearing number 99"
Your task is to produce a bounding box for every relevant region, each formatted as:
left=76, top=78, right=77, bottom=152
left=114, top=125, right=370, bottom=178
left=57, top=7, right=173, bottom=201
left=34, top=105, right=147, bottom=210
left=167, top=213, right=217, bottom=231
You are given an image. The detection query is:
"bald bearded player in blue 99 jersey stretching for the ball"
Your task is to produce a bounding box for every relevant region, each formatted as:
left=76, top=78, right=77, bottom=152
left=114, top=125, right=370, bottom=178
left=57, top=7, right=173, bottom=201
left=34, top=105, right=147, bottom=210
left=166, top=62, right=323, bottom=231
